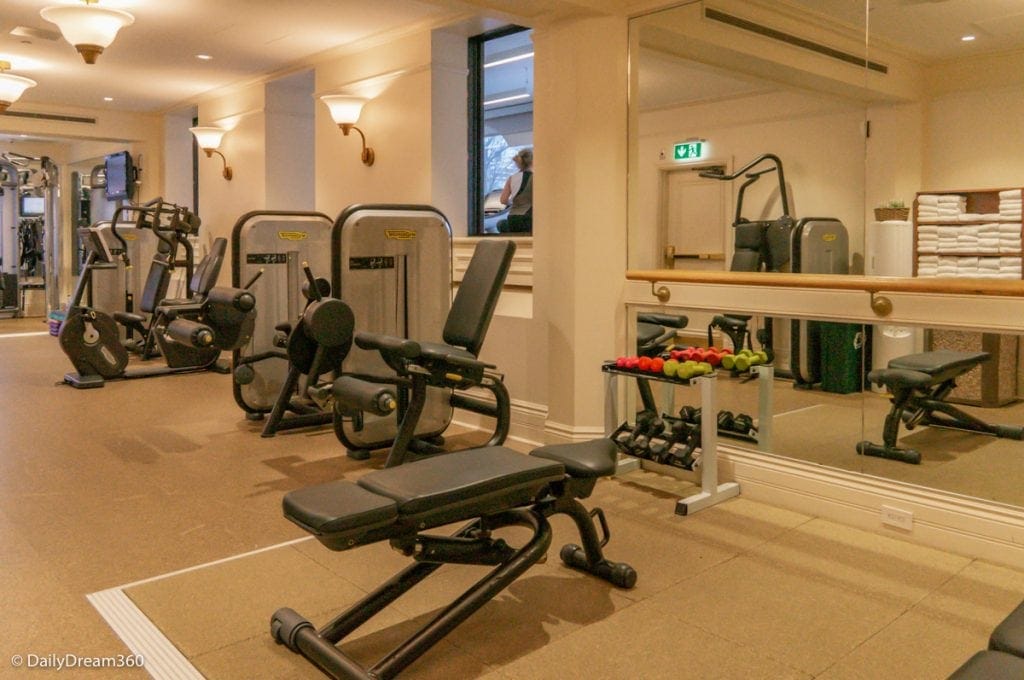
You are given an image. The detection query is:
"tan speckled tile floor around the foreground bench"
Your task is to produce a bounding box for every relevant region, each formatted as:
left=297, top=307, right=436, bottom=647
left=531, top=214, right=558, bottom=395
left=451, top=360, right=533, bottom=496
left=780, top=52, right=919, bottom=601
left=0, top=320, right=1024, bottom=680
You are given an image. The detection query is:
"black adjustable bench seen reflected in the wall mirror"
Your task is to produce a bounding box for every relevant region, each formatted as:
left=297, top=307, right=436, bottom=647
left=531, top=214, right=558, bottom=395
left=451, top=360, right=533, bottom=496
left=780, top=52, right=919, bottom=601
left=857, top=349, right=1024, bottom=464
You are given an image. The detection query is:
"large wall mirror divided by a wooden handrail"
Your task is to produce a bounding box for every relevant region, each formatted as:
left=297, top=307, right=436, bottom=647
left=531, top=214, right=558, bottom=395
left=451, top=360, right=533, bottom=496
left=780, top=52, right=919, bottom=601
left=628, top=0, right=1024, bottom=506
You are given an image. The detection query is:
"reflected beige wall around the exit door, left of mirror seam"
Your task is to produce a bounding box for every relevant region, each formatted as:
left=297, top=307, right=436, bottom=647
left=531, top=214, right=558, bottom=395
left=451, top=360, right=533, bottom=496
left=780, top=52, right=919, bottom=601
left=630, top=90, right=864, bottom=268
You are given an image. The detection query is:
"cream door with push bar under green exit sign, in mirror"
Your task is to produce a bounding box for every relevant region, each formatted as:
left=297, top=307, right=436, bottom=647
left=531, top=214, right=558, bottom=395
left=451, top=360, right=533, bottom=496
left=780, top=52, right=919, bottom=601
left=659, top=166, right=731, bottom=271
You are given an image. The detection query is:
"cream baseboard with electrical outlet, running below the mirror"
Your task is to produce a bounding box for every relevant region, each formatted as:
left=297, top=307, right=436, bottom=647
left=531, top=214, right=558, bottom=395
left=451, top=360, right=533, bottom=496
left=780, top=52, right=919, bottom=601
left=719, top=445, right=1024, bottom=568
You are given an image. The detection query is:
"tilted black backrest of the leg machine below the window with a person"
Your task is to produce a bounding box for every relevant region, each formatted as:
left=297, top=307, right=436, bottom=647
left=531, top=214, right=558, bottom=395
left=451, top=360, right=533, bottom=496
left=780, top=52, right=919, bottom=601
left=442, top=239, right=515, bottom=356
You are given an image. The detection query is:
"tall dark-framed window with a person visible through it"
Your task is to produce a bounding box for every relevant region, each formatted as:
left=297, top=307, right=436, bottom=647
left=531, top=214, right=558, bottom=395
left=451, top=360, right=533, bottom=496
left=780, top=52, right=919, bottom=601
left=469, top=26, right=534, bottom=235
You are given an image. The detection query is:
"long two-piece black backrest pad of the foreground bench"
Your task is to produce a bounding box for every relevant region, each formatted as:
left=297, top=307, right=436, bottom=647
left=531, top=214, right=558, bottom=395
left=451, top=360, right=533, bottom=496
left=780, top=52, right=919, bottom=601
left=284, top=447, right=565, bottom=550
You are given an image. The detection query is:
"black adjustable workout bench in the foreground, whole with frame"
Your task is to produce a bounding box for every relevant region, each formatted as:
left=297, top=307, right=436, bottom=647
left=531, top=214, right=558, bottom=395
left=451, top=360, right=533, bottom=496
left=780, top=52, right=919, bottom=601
left=270, top=439, right=637, bottom=679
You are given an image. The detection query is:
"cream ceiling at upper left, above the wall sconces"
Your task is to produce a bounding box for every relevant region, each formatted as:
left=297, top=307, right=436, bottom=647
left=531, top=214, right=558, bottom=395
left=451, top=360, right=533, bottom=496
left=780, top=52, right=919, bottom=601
left=0, top=0, right=455, bottom=112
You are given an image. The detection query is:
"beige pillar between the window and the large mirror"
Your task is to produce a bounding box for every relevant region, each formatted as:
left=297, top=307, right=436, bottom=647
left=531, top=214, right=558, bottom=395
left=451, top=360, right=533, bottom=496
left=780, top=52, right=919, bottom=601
left=536, top=17, right=628, bottom=438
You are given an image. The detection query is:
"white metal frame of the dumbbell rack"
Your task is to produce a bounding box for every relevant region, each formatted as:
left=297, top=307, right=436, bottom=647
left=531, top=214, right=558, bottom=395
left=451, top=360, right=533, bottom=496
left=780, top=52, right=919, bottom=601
left=601, top=363, right=739, bottom=515
